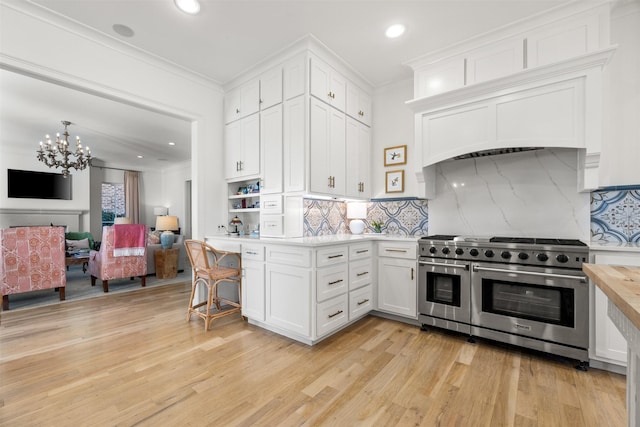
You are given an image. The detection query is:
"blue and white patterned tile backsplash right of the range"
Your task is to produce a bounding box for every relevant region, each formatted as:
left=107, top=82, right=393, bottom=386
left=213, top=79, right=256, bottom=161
left=591, top=186, right=640, bottom=243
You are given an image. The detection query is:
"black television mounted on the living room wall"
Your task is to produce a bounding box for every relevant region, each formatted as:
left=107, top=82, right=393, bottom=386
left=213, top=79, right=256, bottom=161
left=7, top=169, right=71, bottom=200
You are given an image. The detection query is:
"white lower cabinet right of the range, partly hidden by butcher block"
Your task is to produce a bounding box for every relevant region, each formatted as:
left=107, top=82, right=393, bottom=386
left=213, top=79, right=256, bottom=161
left=590, top=250, right=640, bottom=372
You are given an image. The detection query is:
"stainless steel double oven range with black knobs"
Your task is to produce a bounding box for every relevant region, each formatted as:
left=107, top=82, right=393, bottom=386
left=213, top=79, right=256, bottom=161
left=418, top=235, right=589, bottom=368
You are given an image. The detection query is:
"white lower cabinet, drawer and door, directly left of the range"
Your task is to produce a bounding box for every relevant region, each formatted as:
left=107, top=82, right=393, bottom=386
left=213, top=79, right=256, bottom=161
left=378, top=242, right=418, bottom=319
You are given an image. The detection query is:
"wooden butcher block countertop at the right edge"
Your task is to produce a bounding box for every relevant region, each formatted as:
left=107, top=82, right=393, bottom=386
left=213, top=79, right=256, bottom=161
left=582, top=264, right=640, bottom=329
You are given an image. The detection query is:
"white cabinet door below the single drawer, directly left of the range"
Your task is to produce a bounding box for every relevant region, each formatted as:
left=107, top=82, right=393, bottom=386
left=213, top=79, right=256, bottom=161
left=378, top=258, right=418, bottom=319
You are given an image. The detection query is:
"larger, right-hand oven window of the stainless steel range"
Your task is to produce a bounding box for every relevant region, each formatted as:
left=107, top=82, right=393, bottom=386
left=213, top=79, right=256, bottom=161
left=482, top=279, right=574, bottom=328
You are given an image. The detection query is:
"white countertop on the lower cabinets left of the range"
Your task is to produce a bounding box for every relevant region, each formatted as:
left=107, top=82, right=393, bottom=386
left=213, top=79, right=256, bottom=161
left=205, top=233, right=422, bottom=247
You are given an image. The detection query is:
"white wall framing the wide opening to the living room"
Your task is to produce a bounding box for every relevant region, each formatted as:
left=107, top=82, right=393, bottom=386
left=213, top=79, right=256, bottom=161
left=0, top=0, right=226, bottom=238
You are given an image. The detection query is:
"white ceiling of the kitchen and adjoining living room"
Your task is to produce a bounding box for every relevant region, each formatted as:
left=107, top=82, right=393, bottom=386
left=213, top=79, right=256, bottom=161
left=0, top=0, right=567, bottom=169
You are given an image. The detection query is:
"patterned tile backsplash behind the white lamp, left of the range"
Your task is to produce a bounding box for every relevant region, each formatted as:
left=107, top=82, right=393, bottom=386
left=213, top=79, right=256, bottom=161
left=304, top=199, right=429, bottom=237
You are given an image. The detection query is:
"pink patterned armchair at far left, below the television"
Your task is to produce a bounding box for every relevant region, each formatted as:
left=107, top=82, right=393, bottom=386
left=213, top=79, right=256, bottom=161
left=0, top=227, right=67, bottom=310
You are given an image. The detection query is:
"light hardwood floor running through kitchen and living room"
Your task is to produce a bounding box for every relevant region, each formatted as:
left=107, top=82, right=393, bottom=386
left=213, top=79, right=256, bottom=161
left=0, top=285, right=626, bottom=426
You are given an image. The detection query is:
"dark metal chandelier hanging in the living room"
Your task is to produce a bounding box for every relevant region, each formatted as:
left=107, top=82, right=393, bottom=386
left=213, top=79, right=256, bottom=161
left=37, top=120, right=91, bottom=178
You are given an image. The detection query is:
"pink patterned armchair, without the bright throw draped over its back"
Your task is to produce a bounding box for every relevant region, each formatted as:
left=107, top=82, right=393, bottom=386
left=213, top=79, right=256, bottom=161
left=89, top=224, right=147, bottom=292
